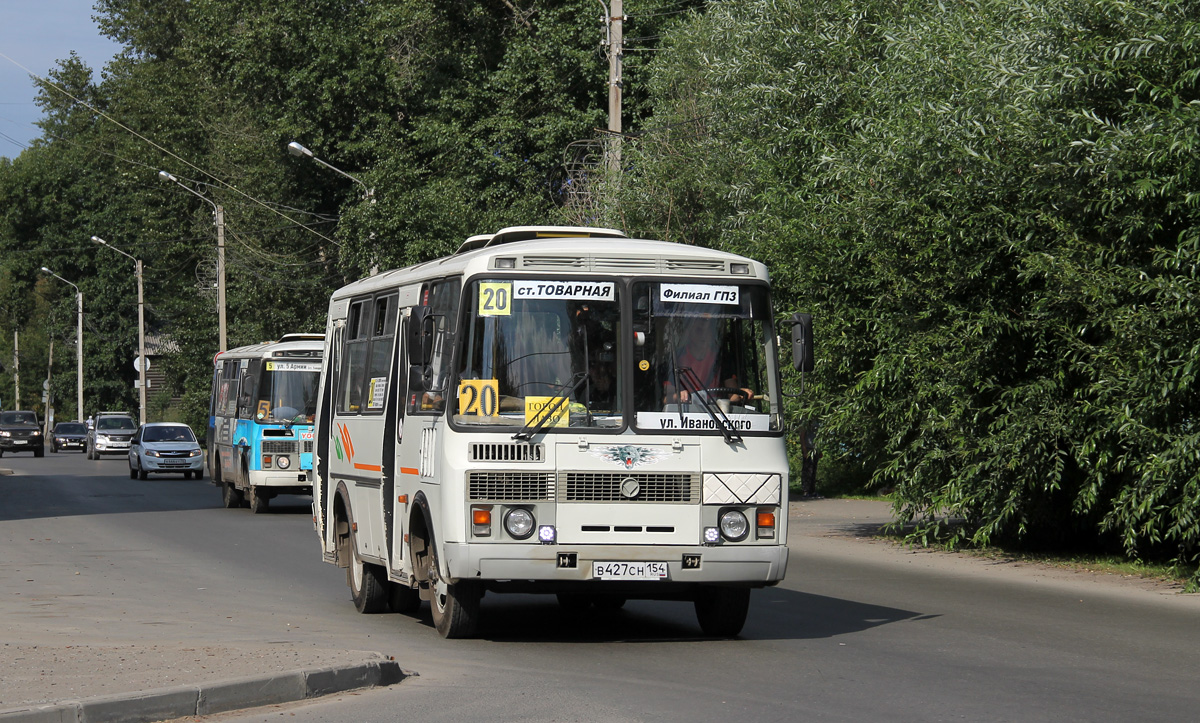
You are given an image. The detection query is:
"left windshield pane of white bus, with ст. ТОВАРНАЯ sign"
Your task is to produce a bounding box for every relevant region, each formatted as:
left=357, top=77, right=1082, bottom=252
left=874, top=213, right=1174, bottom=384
left=451, top=279, right=624, bottom=430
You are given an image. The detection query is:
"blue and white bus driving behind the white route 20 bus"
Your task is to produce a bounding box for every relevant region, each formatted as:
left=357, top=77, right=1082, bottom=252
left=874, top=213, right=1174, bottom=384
left=208, top=334, right=324, bottom=513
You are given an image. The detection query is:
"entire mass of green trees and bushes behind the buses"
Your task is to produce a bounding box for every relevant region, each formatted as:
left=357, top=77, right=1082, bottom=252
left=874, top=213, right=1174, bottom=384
left=0, top=0, right=1200, bottom=574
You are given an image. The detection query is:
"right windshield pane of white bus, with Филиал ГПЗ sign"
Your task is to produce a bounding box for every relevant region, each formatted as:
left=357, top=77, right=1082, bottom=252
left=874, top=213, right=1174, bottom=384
left=632, top=281, right=781, bottom=432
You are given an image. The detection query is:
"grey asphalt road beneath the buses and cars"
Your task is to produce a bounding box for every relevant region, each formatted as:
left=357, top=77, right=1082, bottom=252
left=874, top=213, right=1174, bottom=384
left=0, top=453, right=1200, bottom=722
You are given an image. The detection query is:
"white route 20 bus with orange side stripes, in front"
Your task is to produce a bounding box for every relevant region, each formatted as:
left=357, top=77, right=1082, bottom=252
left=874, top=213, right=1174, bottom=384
left=313, top=227, right=811, bottom=638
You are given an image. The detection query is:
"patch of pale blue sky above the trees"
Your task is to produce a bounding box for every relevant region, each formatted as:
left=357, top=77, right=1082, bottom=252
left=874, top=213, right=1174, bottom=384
left=0, top=0, right=121, bottom=159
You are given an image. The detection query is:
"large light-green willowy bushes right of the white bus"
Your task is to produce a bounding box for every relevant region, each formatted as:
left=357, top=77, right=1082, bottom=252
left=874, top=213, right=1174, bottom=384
left=620, top=0, right=1200, bottom=574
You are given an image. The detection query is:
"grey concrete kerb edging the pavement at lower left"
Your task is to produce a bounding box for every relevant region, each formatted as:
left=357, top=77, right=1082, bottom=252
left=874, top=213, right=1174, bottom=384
left=0, top=661, right=412, bottom=723
